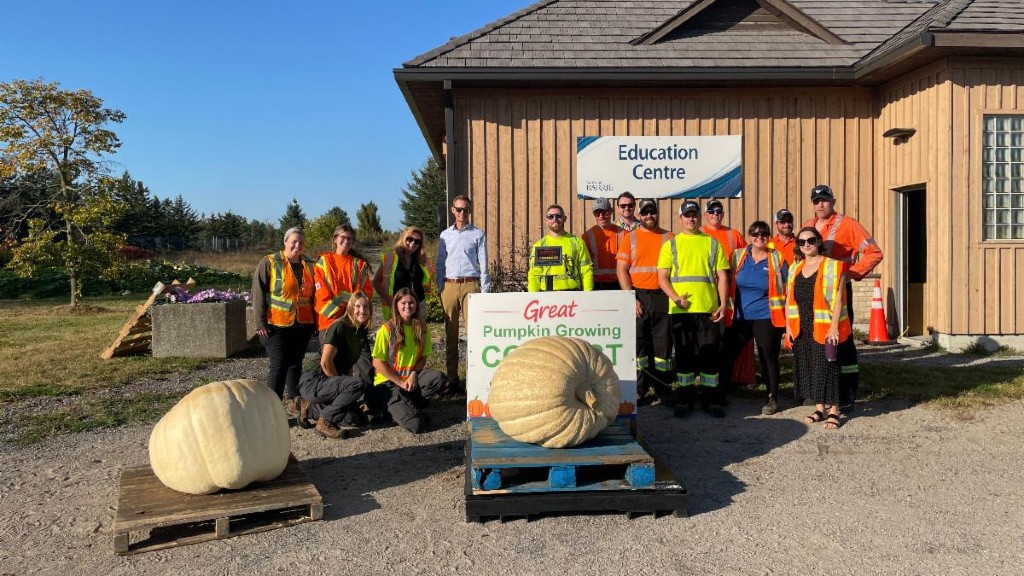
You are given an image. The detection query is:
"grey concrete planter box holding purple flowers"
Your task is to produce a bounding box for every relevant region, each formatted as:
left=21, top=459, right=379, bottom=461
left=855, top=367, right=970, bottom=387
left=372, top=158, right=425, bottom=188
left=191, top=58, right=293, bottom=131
left=153, top=300, right=249, bottom=358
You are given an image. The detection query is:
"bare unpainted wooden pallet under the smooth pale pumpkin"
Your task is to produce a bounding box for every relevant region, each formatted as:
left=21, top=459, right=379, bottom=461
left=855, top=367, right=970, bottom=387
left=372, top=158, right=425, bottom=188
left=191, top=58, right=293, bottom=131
left=114, top=456, right=324, bottom=554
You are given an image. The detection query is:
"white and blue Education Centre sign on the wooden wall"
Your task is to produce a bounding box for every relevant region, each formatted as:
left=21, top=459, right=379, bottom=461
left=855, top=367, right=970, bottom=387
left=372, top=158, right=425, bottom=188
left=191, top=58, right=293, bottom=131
left=577, top=136, right=743, bottom=198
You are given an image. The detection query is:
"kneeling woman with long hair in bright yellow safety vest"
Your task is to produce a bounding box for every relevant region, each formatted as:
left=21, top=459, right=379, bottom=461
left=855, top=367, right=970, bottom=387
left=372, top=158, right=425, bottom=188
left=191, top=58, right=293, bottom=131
left=367, top=288, right=447, bottom=434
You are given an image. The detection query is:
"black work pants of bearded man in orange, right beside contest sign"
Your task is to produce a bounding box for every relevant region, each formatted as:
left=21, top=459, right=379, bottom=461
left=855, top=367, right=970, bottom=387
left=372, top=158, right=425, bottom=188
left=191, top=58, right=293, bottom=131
left=635, top=288, right=676, bottom=401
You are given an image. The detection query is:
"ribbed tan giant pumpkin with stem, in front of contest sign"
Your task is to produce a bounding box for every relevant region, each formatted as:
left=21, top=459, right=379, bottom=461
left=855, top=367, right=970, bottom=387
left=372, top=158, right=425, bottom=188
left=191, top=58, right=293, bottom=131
left=487, top=336, right=620, bottom=448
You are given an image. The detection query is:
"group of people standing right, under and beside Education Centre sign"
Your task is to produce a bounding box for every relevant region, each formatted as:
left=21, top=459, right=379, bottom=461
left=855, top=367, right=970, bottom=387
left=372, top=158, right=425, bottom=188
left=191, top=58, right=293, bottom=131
left=528, top=186, right=883, bottom=428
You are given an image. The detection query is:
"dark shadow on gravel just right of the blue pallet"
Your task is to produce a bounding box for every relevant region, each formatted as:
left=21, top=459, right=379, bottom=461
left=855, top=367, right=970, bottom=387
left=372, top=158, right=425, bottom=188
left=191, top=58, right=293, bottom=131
left=639, top=399, right=813, bottom=516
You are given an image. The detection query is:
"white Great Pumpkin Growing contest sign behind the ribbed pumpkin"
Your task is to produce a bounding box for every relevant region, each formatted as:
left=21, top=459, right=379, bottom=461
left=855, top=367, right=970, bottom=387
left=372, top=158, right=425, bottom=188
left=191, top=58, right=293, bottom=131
left=466, top=290, right=637, bottom=417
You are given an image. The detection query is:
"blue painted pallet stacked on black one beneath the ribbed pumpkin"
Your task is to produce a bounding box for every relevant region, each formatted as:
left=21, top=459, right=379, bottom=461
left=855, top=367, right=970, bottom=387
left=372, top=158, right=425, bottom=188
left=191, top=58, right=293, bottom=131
left=469, top=418, right=654, bottom=495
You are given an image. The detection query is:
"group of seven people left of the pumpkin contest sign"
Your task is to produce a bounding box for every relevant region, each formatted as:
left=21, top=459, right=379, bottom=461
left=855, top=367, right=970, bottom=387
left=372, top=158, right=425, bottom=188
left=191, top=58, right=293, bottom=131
left=252, top=197, right=489, bottom=439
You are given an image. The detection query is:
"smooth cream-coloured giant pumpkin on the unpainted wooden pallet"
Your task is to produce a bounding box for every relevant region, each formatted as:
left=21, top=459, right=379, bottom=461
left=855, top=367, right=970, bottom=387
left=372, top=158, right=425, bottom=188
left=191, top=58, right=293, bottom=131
left=150, top=380, right=291, bottom=494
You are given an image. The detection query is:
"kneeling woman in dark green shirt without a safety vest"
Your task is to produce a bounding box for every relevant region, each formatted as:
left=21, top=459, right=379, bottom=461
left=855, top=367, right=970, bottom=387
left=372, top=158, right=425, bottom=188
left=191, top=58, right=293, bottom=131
left=298, top=291, right=373, bottom=438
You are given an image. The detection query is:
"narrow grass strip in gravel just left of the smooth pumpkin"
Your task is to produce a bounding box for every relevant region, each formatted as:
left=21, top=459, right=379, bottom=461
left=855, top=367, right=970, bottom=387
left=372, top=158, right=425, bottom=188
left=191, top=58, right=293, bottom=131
left=14, top=393, right=181, bottom=445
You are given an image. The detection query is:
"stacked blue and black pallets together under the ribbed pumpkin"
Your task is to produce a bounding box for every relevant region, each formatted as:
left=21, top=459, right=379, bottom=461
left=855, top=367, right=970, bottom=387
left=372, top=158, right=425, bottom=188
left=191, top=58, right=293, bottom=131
left=465, top=418, right=689, bottom=522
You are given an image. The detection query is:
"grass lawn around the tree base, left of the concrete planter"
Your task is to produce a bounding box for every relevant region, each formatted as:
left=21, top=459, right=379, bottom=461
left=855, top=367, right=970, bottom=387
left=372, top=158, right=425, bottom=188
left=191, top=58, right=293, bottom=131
left=0, top=295, right=222, bottom=402
